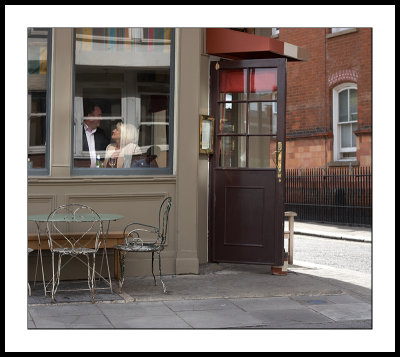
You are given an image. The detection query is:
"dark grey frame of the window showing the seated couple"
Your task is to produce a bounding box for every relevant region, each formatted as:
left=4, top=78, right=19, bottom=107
left=71, top=28, right=175, bottom=177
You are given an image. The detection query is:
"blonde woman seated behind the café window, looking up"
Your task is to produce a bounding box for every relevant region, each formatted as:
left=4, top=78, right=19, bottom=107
left=104, top=122, right=142, bottom=168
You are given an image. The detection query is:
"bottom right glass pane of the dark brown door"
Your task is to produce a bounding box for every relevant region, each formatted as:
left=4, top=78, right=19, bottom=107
left=249, top=136, right=276, bottom=168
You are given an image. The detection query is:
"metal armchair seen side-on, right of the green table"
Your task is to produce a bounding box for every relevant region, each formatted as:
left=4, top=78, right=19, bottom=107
left=114, top=197, right=172, bottom=293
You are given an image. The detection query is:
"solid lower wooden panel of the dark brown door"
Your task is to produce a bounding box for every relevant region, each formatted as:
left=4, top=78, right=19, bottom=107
left=215, top=170, right=275, bottom=264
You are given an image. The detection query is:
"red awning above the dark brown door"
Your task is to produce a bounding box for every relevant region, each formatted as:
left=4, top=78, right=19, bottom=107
left=206, top=28, right=308, bottom=61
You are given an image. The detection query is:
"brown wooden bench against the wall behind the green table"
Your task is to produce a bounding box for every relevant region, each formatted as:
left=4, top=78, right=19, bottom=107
left=28, top=232, right=124, bottom=279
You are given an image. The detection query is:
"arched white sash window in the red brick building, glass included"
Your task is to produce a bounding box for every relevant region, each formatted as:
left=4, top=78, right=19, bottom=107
left=333, top=84, right=358, bottom=160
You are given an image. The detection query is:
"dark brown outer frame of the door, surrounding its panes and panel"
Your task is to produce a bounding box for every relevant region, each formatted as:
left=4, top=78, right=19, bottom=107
left=208, top=58, right=287, bottom=265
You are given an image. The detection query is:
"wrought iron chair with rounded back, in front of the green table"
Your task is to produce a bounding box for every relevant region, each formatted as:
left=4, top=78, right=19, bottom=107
left=47, top=203, right=103, bottom=303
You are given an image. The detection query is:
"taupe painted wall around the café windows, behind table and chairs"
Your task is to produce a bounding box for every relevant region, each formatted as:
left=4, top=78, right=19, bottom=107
left=27, top=28, right=208, bottom=279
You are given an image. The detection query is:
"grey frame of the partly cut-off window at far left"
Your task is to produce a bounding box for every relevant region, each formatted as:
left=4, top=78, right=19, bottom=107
left=27, top=27, right=53, bottom=176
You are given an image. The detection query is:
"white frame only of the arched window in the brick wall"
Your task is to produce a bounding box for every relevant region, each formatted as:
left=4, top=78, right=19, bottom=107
left=332, top=83, right=358, bottom=161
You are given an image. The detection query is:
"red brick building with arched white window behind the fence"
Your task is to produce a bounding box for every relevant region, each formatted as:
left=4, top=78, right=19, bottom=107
left=273, top=28, right=372, bottom=169
